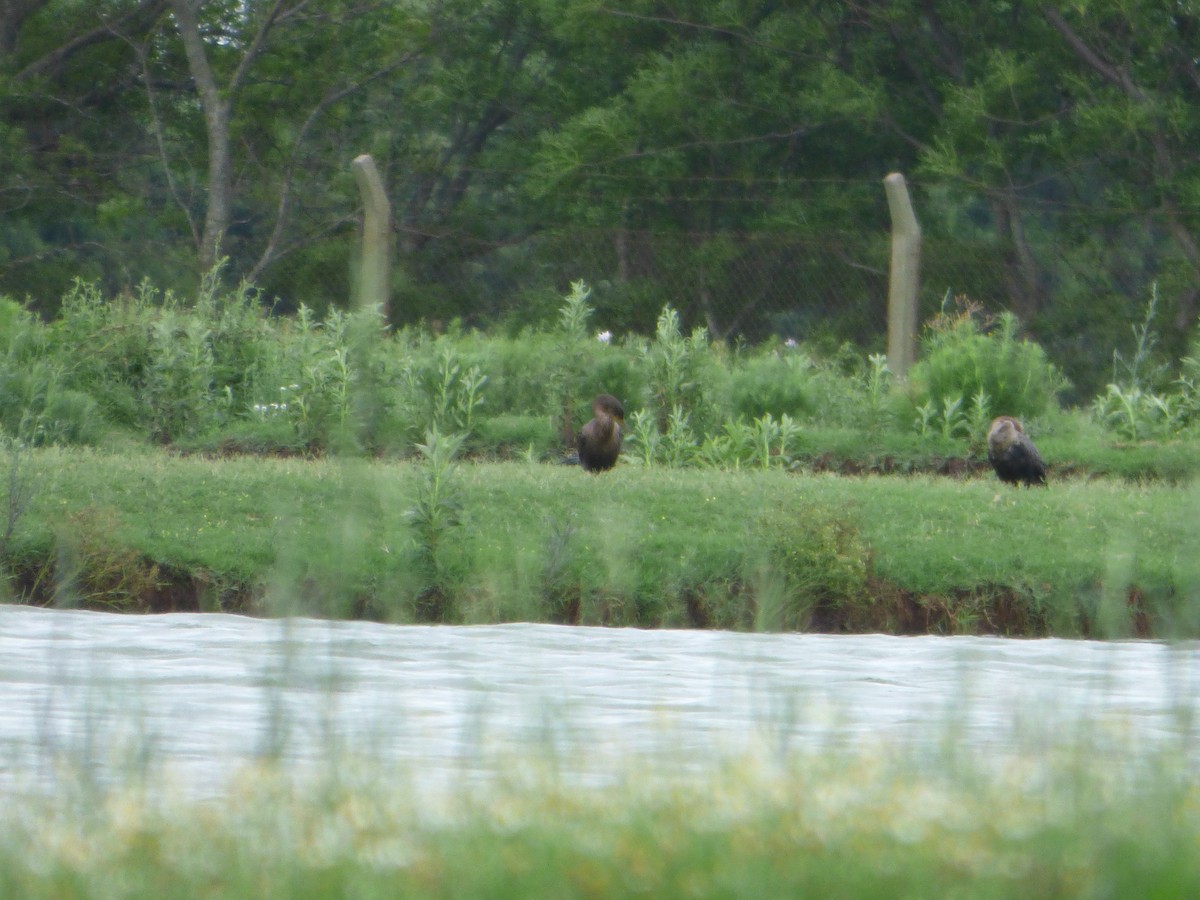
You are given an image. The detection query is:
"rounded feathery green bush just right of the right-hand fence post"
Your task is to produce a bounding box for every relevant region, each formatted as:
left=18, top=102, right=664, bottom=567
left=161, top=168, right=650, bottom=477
left=910, top=305, right=1064, bottom=436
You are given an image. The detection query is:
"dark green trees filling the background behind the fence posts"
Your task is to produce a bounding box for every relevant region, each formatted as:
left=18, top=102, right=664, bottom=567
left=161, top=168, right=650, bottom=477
left=0, top=0, right=1200, bottom=402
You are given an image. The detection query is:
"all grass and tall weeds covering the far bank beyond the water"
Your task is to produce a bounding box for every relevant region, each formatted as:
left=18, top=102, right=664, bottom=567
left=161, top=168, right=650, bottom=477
left=0, top=272, right=1200, bottom=635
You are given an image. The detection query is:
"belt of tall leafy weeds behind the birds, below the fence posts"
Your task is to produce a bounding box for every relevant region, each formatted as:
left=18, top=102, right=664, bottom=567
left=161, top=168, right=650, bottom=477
left=0, top=280, right=1113, bottom=468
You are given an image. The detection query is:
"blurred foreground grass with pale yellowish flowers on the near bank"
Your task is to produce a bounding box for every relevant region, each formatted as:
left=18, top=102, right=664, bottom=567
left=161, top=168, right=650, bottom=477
left=0, top=748, right=1200, bottom=899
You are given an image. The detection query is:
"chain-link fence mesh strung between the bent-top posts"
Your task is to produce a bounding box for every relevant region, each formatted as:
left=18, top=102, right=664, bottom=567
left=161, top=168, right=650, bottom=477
left=150, top=175, right=1200, bottom=402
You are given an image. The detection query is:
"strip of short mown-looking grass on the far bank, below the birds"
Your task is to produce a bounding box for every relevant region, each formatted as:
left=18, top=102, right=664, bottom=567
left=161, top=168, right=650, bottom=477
left=4, top=448, right=1200, bottom=636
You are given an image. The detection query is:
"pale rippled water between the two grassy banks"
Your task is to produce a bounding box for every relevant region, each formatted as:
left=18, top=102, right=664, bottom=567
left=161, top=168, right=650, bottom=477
left=0, top=606, right=1200, bottom=794
